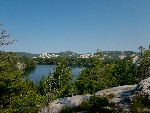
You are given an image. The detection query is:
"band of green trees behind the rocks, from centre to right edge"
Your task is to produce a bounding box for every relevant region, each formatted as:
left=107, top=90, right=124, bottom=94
left=38, top=50, right=150, bottom=98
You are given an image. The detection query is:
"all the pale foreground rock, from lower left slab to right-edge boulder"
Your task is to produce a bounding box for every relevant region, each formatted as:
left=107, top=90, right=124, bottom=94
left=39, top=77, right=150, bottom=113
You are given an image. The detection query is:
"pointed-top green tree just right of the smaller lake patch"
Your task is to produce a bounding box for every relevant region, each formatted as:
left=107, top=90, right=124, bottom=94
left=75, top=51, right=108, bottom=94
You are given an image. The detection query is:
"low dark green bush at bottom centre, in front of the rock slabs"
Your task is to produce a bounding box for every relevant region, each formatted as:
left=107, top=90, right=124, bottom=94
left=61, top=96, right=114, bottom=113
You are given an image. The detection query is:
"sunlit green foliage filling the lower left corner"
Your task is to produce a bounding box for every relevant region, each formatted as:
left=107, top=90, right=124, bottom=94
left=0, top=54, right=45, bottom=113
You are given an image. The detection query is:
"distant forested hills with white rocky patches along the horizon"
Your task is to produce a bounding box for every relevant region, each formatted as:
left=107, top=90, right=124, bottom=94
left=14, top=51, right=137, bottom=59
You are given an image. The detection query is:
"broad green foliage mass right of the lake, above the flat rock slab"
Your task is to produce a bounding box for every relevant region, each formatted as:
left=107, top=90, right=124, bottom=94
left=75, top=52, right=139, bottom=94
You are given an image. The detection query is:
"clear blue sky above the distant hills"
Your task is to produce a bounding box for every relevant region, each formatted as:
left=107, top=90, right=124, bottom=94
left=0, top=0, right=150, bottom=53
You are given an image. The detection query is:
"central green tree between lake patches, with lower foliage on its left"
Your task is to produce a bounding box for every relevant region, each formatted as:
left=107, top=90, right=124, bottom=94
left=37, top=58, right=74, bottom=100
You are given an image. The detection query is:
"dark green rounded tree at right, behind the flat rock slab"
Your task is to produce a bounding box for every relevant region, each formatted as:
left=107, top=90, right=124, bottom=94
left=112, top=57, right=139, bottom=86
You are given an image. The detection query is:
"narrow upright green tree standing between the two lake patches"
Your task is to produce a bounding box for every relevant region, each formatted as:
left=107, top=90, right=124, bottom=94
left=52, top=58, right=73, bottom=97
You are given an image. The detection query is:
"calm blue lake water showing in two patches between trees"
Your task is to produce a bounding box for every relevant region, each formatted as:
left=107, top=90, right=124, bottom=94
left=29, top=65, right=82, bottom=82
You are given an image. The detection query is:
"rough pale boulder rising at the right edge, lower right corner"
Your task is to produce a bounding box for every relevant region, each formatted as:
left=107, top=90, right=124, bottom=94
left=114, top=77, right=150, bottom=113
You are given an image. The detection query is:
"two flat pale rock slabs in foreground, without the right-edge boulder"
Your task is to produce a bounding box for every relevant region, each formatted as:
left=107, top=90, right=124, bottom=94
left=39, top=85, right=136, bottom=113
